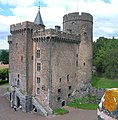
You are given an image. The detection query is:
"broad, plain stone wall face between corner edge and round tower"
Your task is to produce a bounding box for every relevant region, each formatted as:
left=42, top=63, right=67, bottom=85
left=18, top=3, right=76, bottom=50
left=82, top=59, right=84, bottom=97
left=50, top=41, right=78, bottom=109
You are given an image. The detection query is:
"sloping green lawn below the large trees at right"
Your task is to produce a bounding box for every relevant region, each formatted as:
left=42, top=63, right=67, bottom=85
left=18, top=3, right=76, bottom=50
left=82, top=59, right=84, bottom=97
left=91, top=76, right=118, bottom=88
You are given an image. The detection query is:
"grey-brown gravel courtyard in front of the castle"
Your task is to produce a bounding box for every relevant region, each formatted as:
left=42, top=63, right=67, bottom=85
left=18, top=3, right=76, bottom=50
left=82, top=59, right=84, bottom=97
left=0, top=86, right=97, bottom=120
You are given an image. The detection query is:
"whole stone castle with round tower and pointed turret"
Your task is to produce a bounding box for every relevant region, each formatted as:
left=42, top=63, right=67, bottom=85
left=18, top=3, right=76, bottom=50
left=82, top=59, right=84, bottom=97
left=8, top=9, right=93, bottom=116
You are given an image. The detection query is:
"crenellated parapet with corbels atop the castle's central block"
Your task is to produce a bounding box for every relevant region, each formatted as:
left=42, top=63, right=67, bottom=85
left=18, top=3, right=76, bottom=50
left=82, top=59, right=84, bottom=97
left=32, top=29, right=80, bottom=43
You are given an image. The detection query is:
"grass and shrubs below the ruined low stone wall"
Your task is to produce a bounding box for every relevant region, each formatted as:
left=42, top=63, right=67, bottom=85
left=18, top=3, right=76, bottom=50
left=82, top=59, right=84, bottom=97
left=68, top=94, right=98, bottom=110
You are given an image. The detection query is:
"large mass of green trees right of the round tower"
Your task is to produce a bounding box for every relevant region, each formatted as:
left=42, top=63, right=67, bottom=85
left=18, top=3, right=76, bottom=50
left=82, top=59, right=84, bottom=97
left=93, top=37, right=118, bottom=79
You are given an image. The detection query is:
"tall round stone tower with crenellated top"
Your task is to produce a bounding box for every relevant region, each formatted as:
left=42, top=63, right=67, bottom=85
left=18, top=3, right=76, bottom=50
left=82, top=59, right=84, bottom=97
left=63, top=12, right=93, bottom=86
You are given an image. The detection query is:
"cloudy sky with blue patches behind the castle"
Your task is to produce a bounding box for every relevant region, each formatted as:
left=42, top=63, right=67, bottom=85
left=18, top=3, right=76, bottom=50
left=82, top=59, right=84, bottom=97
left=0, top=0, right=118, bottom=49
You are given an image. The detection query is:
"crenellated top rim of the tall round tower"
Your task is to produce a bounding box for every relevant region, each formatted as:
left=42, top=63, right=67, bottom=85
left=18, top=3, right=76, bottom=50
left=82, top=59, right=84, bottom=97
left=63, top=12, right=93, bottom=22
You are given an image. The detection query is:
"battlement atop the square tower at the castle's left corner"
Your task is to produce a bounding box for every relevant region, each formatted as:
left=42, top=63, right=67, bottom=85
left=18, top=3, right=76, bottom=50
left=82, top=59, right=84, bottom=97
left=10, top=21, right=34, bottom=33
